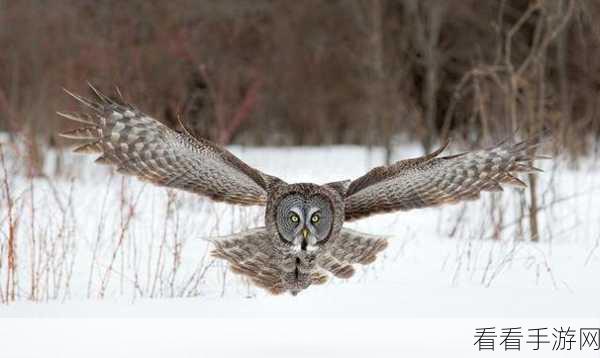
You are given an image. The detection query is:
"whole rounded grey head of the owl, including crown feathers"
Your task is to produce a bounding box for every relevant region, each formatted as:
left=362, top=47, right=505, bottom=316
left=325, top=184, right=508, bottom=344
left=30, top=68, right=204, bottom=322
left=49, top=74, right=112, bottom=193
left=265, top=183, right=344, bottom=253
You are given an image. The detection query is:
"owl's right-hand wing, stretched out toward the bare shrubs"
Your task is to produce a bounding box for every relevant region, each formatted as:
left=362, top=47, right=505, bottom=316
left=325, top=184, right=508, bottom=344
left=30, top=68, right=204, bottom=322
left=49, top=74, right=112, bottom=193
left=344, top=138, right=539, bottom=220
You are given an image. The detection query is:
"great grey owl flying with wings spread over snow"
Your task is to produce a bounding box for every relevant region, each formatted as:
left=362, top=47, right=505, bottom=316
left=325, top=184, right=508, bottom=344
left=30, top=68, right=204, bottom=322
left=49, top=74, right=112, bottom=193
left=58, top=86, right=539, bottom=295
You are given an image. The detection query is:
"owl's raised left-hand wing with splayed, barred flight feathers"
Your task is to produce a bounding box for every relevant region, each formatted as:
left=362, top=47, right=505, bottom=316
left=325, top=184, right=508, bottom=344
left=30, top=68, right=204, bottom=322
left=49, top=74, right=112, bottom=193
left=58, top=87, right=281, bottom=205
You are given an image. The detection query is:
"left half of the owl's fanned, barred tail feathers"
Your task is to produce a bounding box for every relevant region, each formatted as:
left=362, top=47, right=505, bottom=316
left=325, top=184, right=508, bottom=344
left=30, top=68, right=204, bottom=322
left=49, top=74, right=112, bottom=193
left=210, top=227, right=287, bottom=294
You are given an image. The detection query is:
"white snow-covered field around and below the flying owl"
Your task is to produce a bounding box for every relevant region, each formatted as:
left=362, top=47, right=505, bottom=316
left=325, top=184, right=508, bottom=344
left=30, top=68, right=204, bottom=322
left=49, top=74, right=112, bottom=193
left=0, top=145, right=600, bottom=357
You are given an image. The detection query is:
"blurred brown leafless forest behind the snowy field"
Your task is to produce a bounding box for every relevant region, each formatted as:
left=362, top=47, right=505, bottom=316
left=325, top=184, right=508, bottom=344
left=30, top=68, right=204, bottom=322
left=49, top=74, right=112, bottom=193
left=0, top=0, right=600, bottom=160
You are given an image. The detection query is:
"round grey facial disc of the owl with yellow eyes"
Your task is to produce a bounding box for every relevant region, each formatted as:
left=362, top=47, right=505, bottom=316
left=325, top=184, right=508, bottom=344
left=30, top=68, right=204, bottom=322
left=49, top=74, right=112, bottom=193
left=275, top=193, right=333, bottom=252
